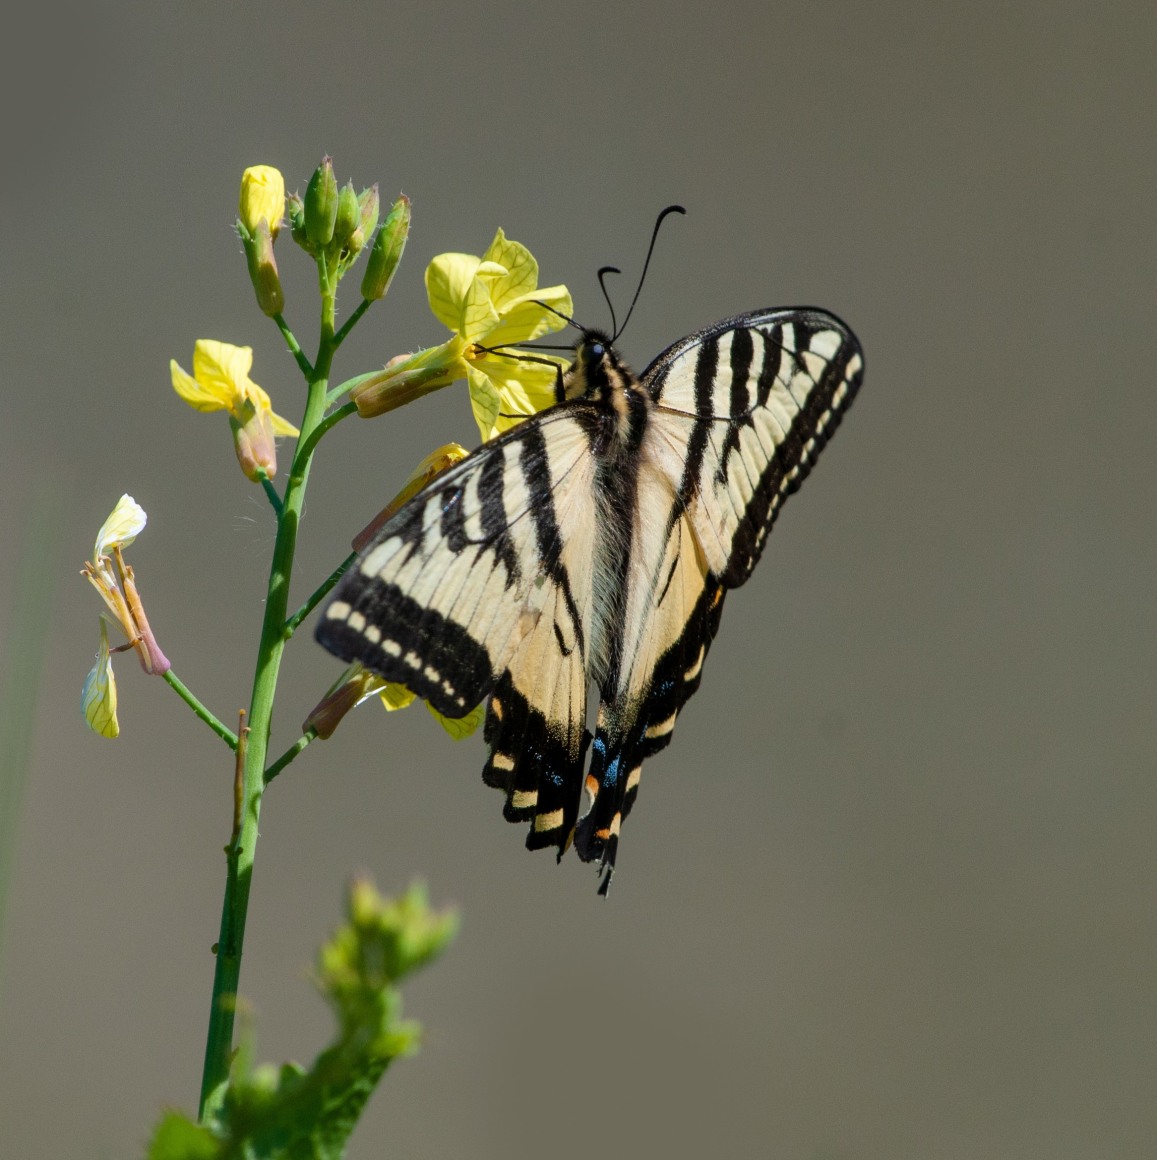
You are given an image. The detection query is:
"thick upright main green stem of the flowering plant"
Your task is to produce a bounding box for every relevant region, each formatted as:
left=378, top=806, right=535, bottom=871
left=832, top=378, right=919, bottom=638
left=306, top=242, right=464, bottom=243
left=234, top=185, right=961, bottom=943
left=194, top=283, right=334, bottom=1118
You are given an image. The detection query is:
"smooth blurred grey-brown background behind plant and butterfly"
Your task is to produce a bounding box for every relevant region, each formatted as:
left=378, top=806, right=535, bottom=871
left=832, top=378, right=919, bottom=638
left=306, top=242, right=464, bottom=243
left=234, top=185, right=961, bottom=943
left=0, top=0, right=1157, bottom=1160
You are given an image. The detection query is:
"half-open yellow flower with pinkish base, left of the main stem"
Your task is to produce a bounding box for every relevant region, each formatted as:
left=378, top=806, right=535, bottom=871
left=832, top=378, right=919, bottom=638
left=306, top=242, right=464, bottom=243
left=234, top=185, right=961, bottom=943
left=168, top=339, right=298, bottom=481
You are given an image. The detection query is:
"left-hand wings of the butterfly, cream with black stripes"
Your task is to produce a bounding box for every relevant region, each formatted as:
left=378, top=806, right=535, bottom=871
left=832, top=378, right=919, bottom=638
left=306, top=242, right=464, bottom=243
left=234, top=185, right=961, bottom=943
left=317, top=403, right=603, bottom=849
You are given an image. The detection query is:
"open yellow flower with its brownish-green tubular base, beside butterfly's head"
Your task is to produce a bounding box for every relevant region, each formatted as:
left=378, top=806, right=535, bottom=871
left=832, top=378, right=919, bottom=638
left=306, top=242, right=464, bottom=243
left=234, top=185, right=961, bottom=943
left=349, top=230, right=573, bottom=440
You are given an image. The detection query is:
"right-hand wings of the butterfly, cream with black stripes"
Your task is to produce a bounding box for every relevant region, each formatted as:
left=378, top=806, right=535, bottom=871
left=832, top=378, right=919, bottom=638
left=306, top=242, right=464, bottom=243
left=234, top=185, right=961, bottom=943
left=576, top=307, right=863, bottom=891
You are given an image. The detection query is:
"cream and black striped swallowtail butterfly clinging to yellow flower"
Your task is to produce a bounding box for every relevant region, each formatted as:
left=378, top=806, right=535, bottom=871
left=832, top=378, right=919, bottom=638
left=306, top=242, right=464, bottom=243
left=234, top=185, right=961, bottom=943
left=317, top=307, right=863, bottom=893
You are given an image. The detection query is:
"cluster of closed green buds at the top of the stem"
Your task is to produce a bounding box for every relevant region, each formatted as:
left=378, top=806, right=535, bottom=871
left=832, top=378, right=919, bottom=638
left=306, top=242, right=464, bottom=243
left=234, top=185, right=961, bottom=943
left=288, top=157, right=410, bottom=292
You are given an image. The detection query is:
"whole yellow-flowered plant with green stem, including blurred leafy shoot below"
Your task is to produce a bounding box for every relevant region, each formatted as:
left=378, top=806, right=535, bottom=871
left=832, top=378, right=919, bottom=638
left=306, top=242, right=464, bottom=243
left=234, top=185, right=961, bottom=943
left=81, top=158, right=572, bottom=1160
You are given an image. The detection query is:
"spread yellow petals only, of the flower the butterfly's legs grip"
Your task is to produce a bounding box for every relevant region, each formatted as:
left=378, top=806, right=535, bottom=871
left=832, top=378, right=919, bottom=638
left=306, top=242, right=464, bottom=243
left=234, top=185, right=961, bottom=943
left=426, top=230, right=574, bottom=441
